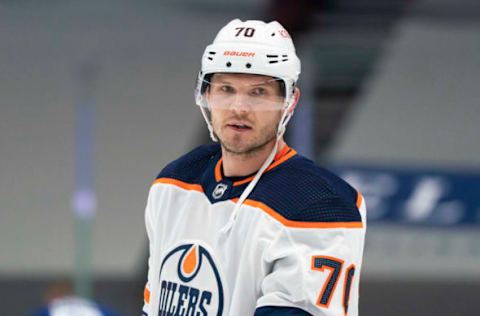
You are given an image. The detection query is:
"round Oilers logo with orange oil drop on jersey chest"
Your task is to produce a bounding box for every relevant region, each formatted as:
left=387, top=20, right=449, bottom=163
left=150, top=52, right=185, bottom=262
left=158, top=243, right=224, bottom=316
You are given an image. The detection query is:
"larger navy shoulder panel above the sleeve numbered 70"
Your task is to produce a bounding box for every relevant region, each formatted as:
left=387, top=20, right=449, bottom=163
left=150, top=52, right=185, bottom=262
left=249, top=155, right=361, bottom=222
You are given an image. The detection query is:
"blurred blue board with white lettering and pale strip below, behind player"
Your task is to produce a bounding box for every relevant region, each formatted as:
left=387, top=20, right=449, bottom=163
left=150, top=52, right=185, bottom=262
left=329, top=164, right=480, bottom=281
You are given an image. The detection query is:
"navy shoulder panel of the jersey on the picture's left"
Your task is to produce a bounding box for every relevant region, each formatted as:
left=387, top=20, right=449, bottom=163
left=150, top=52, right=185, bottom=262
left=157, top=144, right=220, bottom=183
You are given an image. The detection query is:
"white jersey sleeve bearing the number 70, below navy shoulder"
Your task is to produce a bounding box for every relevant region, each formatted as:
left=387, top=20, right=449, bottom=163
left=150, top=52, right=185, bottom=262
left=256, top=196, right=365, bottom=316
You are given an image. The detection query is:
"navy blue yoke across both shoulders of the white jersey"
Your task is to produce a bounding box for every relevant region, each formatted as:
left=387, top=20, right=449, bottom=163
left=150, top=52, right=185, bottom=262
left=158, top=144, right=361, bottom=222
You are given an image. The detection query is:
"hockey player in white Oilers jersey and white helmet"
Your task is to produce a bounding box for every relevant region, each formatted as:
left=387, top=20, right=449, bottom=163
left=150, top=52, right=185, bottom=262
left=143, top=19, right=366, bottom=316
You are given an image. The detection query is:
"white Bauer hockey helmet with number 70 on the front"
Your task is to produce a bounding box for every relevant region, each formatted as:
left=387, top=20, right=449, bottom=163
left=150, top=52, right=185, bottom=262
left=195, top=19, right=300, bottom=140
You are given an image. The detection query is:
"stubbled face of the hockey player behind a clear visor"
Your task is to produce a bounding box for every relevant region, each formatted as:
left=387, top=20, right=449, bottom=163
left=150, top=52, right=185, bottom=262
left=206, top=73, right=283, bottom=154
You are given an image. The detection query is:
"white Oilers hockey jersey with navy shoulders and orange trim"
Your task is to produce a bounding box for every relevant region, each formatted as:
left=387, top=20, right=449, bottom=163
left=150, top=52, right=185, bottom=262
left=143, top=145, right=366, bottom=316
